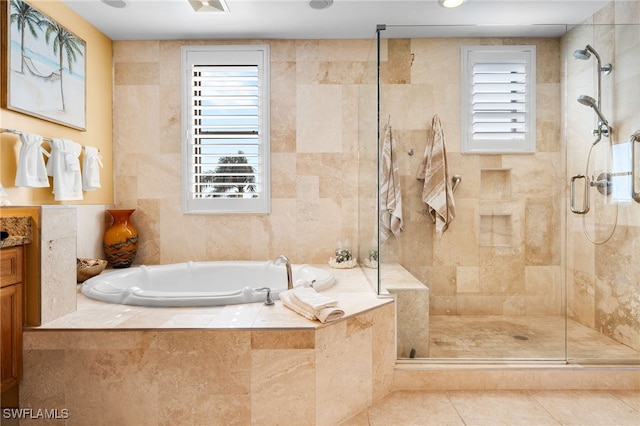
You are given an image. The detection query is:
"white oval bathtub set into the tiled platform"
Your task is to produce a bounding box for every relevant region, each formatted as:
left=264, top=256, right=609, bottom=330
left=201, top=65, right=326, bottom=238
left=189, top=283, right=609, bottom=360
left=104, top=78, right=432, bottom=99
left=81, top=261, right=335, bottom=306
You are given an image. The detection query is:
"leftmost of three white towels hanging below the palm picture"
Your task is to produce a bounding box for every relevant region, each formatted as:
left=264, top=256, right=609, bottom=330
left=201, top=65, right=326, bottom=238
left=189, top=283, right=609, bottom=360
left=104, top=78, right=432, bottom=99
left=15, top=132, right=49, bottom=188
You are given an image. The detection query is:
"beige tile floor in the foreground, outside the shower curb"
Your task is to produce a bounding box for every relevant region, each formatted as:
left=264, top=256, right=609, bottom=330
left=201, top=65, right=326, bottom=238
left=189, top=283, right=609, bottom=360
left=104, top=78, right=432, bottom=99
left=341, top=390, right=640, bottom=426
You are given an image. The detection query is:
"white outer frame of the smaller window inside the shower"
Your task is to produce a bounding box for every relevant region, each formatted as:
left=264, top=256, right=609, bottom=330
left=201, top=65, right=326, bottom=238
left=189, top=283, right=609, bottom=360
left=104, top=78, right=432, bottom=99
left=460, top=45, right=536, bottom=154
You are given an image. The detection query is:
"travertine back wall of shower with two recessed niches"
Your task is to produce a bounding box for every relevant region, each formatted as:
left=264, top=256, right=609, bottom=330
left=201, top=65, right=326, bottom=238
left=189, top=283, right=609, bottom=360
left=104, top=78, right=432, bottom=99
left=381, top=38, right=565, bottom=315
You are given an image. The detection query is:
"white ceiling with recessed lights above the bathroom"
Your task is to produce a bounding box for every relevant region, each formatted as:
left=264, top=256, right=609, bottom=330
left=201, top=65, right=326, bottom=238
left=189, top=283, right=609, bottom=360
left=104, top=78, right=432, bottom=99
left=62, top=0, right=610, bottom=40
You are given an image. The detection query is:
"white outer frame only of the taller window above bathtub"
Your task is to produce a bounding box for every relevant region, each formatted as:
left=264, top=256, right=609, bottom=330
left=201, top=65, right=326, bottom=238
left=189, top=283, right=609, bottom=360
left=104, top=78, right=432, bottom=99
left=181, top=44, right=271, bottom=214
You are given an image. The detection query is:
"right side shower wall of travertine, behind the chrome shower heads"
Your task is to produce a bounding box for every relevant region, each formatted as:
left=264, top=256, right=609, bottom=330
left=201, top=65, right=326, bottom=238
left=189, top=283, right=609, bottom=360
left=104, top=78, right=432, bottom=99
left=563, top=1, right=640, bottom=355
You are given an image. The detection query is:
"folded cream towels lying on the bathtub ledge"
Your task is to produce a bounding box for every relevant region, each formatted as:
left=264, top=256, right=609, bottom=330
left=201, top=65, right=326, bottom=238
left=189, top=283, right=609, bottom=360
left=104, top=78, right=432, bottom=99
left=279, top=287, right=344, bottom=323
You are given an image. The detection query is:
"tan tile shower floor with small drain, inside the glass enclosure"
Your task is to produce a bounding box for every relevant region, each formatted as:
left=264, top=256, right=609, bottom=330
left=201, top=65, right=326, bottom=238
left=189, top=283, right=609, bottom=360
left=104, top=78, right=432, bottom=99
left=424, top=315, right=640, bottom=359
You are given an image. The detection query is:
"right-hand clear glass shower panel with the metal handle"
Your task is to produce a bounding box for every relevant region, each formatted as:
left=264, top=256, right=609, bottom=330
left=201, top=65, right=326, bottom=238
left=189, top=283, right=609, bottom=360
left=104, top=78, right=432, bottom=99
left=562, top=20, right=640, bottom=364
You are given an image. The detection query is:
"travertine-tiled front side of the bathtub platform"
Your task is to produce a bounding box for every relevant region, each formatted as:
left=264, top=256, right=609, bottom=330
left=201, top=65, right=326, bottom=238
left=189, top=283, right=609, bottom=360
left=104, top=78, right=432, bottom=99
left=20, top=303, right=395, bottom=425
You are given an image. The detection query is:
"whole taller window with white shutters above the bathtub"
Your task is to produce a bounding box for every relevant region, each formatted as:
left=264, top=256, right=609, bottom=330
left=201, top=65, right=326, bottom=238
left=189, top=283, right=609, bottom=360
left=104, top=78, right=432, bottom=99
left=182, top=45, right=270, bottom=213
